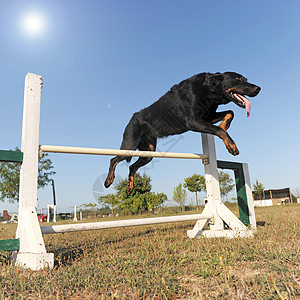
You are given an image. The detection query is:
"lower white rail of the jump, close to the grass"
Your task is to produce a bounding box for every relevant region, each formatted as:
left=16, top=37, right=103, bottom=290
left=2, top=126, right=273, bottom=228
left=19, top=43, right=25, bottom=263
left=41, top=214, right=213, bottom=234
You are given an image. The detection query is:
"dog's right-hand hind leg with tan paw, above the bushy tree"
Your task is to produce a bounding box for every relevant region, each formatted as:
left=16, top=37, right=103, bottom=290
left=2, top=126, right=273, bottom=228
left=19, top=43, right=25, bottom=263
left=127, top=138, right=156, bottom=194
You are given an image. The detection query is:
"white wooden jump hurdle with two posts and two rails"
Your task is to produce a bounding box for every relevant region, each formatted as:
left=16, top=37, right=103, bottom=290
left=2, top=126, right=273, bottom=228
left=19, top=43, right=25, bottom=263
left=5, top=73, right=256, bottom=270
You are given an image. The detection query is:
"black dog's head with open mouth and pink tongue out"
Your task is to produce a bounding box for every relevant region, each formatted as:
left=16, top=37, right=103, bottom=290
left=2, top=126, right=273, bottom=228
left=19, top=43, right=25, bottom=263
left=204, top=72, right=260, bottom=117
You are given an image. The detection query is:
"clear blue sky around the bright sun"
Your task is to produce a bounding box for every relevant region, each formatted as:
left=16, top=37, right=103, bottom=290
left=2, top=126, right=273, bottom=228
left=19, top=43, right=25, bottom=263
left=0, top=0, right=300, bottom=211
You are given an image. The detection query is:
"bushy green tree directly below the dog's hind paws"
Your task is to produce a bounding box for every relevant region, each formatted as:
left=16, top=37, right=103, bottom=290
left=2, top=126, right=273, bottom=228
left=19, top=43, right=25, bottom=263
left=115, top=173, right=167, bottom=214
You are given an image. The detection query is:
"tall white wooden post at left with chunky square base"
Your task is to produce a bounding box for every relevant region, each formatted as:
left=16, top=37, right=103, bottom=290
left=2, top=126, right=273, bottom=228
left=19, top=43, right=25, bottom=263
left=13, top=73, right=54, bottom=270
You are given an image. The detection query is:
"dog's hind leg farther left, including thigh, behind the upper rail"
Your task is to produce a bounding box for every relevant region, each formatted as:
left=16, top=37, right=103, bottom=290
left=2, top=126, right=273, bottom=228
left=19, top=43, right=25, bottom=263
left=104, top=115, right=142, bottom=188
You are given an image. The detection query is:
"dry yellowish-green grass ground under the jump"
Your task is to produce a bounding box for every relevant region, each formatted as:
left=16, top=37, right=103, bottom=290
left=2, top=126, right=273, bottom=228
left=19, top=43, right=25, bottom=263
left=0, top=205, right=300, bottom=299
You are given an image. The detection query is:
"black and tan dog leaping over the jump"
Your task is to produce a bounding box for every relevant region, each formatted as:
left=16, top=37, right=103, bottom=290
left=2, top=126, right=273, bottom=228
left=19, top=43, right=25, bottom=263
left=104, top=72, right=260, bottom=193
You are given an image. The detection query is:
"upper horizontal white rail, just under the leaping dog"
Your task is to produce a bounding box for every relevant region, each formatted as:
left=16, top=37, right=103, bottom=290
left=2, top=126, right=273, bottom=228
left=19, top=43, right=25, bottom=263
left=40, top=145, right=208, bottom=160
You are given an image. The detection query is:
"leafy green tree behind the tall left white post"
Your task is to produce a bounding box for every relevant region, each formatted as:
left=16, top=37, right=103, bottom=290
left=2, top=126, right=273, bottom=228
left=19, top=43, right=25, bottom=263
left=0, top=148, right=55, bottom=203
